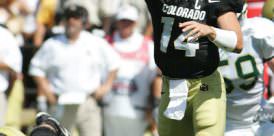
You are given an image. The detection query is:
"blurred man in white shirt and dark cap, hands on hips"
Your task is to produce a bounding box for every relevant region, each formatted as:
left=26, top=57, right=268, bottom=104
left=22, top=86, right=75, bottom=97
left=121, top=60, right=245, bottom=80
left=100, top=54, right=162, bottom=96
left=29, top=5, right=120, bottom=136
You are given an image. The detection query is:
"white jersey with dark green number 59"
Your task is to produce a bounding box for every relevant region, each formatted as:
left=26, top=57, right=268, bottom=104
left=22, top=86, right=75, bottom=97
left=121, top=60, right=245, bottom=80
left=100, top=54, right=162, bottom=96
left=219, top=17, right=274, bottom=127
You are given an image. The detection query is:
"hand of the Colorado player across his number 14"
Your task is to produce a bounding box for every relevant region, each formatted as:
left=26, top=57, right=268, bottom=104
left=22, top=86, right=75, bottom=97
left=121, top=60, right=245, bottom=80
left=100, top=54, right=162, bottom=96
left=179, top=21, right=216, bottom=40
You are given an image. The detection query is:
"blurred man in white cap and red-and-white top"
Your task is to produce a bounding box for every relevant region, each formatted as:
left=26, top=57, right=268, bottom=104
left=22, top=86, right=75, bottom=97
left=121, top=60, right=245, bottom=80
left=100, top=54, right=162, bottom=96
left=104, top=5, right=156, bottom=136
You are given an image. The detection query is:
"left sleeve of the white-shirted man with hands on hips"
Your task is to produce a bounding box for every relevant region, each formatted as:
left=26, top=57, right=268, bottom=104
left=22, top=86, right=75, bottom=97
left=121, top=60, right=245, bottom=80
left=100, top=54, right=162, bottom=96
left=29, top=41, right=52, bottom=77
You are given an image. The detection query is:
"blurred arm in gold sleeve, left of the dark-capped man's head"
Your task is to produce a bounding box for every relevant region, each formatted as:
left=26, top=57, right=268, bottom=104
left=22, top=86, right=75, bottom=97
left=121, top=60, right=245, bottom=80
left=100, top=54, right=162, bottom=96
left=33, top=0, right=58, bottom=47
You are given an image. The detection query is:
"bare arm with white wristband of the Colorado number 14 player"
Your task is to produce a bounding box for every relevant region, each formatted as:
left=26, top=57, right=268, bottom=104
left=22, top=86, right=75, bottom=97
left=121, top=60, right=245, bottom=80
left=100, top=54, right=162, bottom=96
left=179, top=12, right=243, bottom=53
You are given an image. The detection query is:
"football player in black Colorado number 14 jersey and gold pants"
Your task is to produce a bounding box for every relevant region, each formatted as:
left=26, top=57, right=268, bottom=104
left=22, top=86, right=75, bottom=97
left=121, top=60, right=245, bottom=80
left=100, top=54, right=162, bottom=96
left=146, top=0, right=242, bottom=136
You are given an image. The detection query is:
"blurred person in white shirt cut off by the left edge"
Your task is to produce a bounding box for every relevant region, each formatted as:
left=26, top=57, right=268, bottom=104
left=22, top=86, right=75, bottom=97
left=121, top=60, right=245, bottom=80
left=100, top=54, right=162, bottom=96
left=0, top=26, right=22, bottom=127
